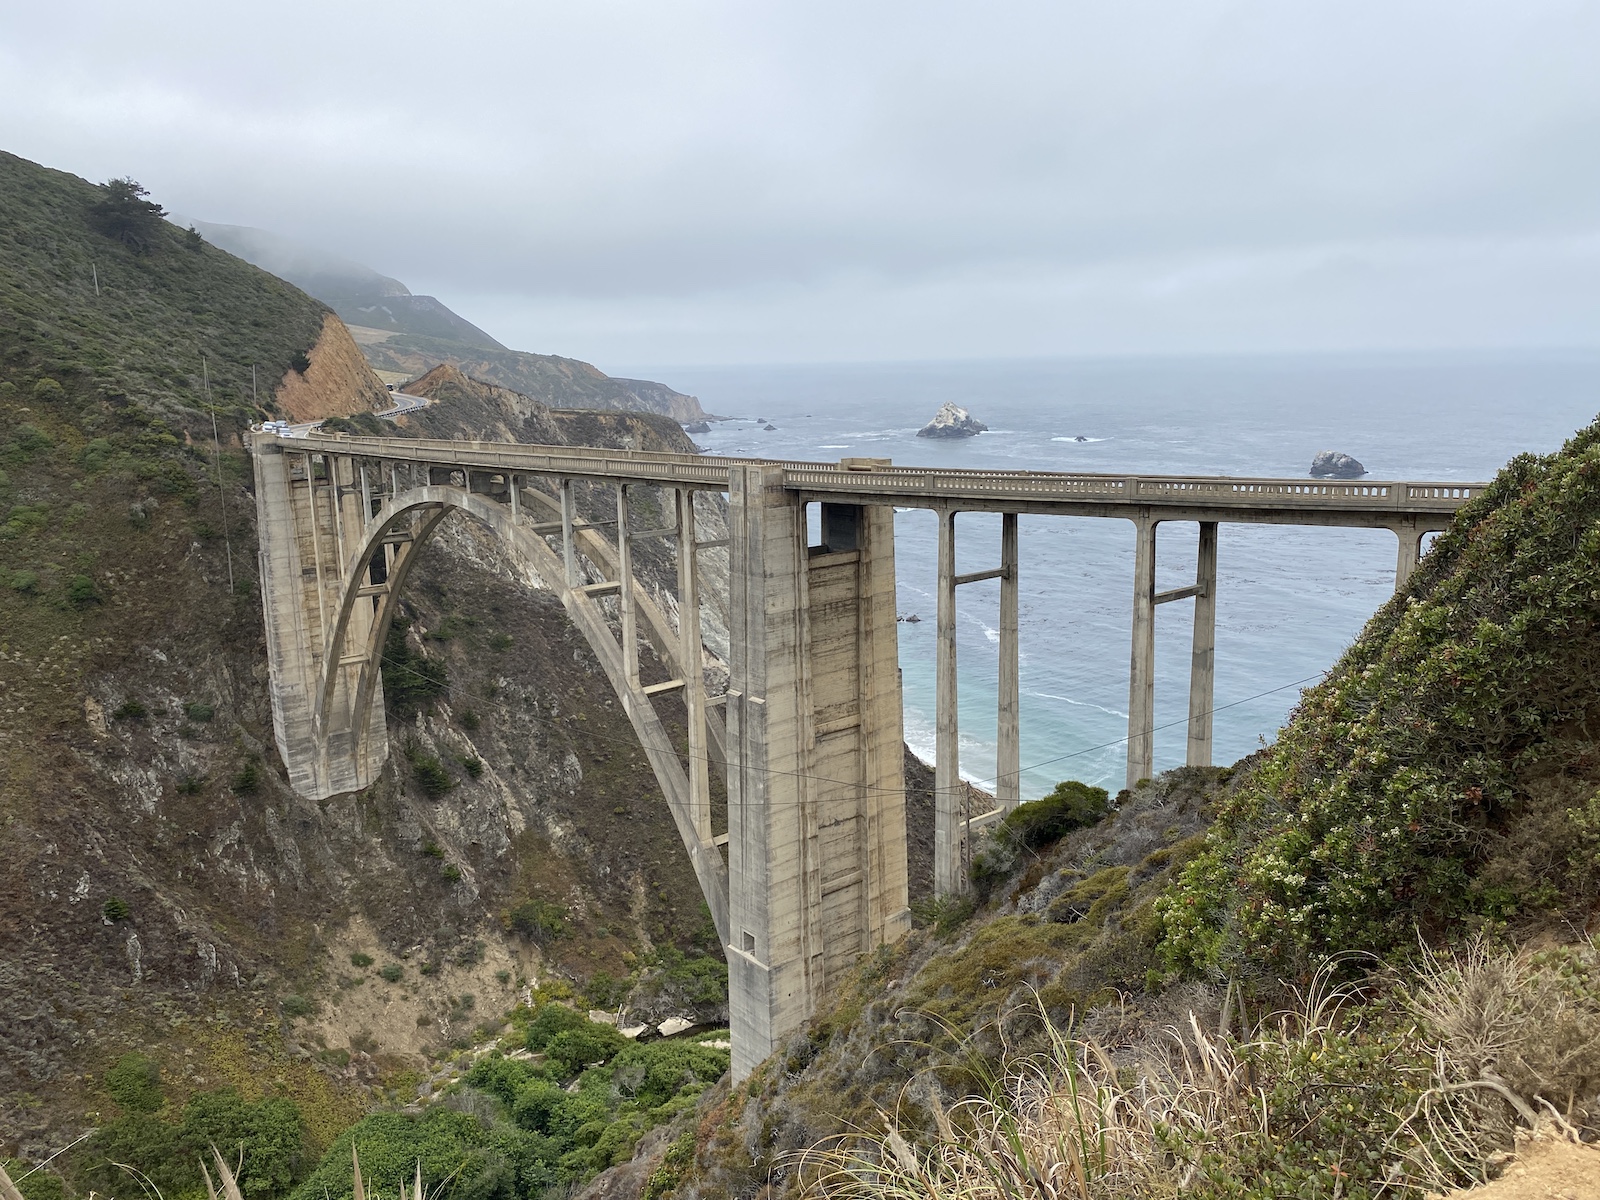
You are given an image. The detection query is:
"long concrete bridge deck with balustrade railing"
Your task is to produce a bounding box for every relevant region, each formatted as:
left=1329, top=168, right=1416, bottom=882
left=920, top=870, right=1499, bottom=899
left=272, top=434, right=1486, bottom=525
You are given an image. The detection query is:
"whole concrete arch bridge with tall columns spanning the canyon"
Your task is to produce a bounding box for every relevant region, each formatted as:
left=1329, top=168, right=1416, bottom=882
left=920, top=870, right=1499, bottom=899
left=251, top=432, right=1483, bottom=1078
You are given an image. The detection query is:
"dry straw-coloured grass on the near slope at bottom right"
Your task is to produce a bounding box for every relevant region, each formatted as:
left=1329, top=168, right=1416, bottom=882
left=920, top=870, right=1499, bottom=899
left=800, top=946, right=1600, bottom=1200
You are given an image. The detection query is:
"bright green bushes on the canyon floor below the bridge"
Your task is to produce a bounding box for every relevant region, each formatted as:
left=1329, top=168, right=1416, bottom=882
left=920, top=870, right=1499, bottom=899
left=6, top=1000, right=728, bottom=1200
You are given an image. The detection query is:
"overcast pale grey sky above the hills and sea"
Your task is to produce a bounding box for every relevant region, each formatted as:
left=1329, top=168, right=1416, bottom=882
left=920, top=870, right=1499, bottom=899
left=0, top=0, right=1600, bottom=370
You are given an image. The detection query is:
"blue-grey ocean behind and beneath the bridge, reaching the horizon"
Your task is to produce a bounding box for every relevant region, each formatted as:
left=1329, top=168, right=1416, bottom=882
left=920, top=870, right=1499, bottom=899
left=629, top=352, right=1600, bottom=798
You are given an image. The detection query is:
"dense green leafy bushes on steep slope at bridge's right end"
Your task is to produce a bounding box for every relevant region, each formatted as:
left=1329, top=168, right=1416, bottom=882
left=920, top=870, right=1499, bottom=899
left=1163, top=427, right=1600, bottom=974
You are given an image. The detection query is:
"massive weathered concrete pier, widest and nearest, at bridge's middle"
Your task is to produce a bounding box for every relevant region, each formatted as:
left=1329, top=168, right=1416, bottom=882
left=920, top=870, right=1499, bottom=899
left=726, top=466, right=910, bottom=1080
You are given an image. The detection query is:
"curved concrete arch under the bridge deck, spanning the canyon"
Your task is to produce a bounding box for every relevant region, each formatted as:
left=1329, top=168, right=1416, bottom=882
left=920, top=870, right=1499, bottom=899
left=314, top=483, right=728, bottom=946
